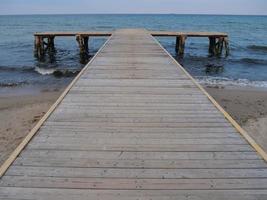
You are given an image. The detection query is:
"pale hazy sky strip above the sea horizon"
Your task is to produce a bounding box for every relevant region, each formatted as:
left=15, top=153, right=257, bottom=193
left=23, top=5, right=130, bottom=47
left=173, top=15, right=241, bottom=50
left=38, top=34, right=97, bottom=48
left=0, top=0, right=267, bottom=15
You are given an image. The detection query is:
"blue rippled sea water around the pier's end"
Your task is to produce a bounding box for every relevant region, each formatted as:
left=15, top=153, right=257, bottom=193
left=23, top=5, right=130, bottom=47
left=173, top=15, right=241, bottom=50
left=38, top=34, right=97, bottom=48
left=0, top=14, right=267, bottom=88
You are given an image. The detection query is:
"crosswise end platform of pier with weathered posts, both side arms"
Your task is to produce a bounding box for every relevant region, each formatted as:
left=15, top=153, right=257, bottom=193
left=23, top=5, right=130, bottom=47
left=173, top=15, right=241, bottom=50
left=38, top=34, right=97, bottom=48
left=34, top=31, right=230, bottom=58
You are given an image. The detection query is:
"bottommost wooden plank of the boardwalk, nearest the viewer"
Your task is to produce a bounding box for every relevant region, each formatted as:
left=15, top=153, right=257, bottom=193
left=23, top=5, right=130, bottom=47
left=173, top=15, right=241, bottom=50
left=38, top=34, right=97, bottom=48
left=0, top=187, right=267, bottom=200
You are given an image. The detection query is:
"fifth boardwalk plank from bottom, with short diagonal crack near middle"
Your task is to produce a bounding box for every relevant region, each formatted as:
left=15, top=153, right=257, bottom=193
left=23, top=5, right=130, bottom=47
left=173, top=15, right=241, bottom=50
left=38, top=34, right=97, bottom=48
left=20, top=149, right=260, bottom=160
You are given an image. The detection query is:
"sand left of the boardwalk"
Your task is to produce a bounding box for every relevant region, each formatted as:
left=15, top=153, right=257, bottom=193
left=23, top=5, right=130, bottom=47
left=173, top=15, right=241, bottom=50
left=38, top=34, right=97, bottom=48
left=0, top=89, right=60, bottom=164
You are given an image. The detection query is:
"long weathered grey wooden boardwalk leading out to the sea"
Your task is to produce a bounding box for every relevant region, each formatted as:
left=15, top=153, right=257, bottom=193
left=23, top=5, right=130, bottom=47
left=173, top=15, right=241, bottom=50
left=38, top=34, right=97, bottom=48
left=0, top=30, right=267, bottom=200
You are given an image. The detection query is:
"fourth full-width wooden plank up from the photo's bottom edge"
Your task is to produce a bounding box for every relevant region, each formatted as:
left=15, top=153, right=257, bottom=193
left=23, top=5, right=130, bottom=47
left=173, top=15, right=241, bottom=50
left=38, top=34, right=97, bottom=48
left=14, top=158, right=266, bottom=169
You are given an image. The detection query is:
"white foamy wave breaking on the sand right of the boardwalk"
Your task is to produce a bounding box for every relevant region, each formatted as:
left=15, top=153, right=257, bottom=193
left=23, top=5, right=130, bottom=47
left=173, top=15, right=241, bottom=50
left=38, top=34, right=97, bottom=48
left=196, top=77, right=267, bottom=88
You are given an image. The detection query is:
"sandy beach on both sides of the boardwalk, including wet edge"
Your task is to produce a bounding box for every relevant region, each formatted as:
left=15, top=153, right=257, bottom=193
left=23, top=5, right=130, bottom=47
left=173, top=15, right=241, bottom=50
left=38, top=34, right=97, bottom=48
left=0, top=85, right=267, bottom=165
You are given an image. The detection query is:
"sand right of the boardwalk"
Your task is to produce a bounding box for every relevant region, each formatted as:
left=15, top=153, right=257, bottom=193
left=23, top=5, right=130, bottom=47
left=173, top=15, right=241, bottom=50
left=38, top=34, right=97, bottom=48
left=206, top=87, right=267, bottom=152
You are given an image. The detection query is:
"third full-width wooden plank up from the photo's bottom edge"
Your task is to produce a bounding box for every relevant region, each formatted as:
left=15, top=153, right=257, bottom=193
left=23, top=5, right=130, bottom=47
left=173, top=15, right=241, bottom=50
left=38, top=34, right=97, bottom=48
left=6, top=166, right=267, bottom=179
